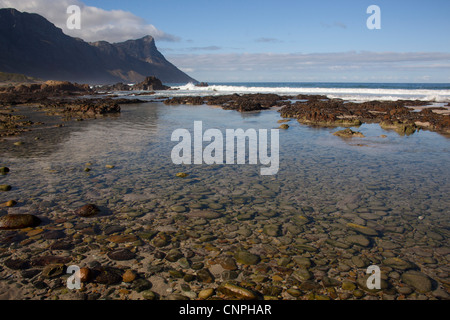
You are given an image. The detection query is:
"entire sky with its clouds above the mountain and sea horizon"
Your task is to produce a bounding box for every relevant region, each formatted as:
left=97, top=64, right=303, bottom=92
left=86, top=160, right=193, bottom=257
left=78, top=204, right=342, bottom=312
left=0, top=0, right=450, bottom=83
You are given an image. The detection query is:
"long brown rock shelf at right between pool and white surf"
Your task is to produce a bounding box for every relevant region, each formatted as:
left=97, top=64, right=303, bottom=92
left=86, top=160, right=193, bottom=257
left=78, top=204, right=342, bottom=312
left=164, top=94, right=450, bottom=135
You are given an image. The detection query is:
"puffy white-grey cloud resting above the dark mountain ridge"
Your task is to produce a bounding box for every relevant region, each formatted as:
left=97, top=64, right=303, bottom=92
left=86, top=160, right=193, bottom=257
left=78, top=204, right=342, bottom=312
left=0, top=0, right=179, bottom=42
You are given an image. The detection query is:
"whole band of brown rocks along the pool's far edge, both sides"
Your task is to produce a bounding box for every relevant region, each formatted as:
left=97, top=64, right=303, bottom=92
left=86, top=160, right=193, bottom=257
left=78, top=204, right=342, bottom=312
left=0, top=77, right=450, bottom=136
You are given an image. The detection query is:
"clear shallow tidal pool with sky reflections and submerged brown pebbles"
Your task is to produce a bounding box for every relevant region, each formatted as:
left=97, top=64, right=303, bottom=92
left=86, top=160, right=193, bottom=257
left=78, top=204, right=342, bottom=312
left=0, top=103, right=450, bottom=299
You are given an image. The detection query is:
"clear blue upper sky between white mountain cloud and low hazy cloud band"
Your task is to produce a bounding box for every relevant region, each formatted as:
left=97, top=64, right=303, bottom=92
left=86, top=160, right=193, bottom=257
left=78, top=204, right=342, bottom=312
left=85, top=0, right=450, bottom=53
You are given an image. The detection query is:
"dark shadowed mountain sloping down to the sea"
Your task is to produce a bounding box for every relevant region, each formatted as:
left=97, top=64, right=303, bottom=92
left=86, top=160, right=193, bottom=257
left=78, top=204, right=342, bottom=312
left=0, top=9, right=197, bottom=84
